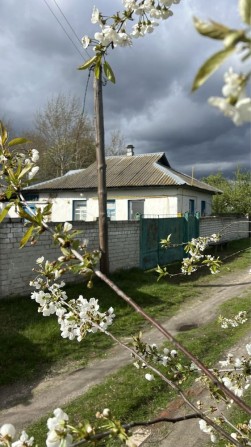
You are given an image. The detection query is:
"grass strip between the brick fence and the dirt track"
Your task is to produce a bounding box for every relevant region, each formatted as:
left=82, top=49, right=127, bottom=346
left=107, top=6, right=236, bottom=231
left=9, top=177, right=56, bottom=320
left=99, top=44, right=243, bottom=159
left=0, top=240, right=249, bottom=385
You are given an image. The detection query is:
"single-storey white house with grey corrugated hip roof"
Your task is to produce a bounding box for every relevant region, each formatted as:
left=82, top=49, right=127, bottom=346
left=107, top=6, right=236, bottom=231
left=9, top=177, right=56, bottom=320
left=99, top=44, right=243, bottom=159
left=19, top=150, right=220, bottom=222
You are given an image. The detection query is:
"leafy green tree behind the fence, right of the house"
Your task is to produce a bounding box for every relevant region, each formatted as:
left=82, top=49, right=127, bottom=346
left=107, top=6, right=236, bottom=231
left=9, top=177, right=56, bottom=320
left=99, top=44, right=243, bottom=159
left=202, top=168, right=251, bottom=214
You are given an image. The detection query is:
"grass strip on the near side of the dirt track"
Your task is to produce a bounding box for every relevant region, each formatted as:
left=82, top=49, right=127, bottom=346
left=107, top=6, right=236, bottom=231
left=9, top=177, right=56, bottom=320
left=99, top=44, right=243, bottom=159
left=28, top=293, right=251, bottom=445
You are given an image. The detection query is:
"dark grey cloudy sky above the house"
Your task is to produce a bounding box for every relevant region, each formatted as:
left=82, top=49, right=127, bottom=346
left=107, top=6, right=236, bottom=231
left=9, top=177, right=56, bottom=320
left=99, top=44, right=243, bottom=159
left=0, top=0, right=251, bottom=178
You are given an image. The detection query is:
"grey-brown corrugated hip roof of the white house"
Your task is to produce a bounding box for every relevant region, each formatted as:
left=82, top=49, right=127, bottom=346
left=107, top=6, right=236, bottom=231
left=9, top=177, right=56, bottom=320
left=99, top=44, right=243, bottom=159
left=25, top=152, right=219, bottom=192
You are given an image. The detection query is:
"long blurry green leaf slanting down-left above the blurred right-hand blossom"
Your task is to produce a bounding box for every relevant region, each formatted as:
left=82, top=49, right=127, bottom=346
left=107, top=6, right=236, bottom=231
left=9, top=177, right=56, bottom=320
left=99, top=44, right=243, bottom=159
left=192, top=48, right=235, bottom=92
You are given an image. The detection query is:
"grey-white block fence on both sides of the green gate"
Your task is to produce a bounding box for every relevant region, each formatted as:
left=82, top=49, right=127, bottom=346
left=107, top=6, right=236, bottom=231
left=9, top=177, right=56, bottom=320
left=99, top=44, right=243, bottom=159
left=0, top=217, right=249, bottom=298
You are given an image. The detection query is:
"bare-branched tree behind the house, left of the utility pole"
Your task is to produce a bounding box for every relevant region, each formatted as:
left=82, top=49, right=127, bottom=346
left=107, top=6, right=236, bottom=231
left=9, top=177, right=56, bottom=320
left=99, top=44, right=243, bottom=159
left=28, top=94, right=95, bottom=180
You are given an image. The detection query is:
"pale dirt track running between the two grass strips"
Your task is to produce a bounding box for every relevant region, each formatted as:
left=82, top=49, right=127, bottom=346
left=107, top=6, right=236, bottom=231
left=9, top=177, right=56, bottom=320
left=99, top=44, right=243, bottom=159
left=0, top=269, right=251, bottom=438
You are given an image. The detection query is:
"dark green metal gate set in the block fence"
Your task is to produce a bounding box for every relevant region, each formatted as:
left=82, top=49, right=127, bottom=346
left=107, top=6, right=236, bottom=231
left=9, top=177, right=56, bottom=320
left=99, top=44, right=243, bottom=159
left=140, top=215, right=199, bottom=270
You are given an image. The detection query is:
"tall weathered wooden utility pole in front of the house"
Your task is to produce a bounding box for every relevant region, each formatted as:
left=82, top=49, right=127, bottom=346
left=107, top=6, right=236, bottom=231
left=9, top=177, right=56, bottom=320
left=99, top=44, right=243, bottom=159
left=93, top=67, right=109, bottom=274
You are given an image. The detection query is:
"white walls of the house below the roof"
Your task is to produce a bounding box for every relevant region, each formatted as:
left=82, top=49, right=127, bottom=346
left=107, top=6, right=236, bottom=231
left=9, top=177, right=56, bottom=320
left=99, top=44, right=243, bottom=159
left=4, top=187, right=214, bottom=222
